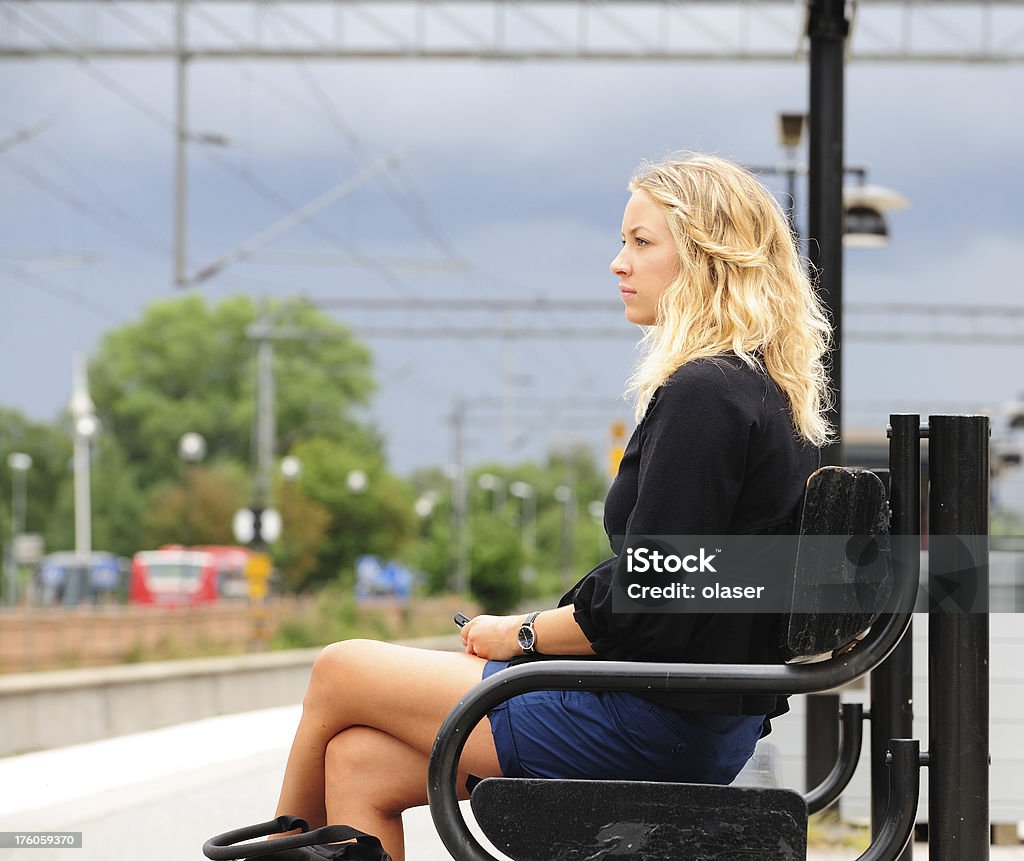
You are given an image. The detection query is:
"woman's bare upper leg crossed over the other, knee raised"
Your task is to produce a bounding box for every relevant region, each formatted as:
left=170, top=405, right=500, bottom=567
left=276, top=640, right=501, bottom=851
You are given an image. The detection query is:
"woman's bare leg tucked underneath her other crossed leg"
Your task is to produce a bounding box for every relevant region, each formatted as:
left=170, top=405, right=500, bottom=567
left=327, top=727, right=469, bottom=861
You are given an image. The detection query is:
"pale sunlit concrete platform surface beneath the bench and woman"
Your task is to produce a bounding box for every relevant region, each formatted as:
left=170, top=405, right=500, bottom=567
left=0, top=706, right=1024, bottom=861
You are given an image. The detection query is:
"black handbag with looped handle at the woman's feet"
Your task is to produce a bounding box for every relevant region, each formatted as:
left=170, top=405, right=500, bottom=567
left=203, top=816, right=391, bottom=861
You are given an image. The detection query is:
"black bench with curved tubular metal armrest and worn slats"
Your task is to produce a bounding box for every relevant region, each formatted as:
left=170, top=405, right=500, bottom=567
left=428, top=467, right=919, bottom=861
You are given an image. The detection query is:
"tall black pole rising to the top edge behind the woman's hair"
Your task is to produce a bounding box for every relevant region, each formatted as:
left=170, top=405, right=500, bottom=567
left=804, top=0, right=849, bottom=789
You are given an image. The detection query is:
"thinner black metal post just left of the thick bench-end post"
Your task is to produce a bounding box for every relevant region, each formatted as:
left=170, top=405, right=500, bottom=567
left=870, top=415, right=921, bottom=861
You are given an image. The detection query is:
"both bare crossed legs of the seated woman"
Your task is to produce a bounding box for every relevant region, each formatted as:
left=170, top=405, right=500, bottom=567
left=275, top=640, right=501, bottom=861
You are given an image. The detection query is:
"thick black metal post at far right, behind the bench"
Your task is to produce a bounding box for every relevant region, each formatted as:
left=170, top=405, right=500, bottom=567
left=928, top=416, right=989, bottom=861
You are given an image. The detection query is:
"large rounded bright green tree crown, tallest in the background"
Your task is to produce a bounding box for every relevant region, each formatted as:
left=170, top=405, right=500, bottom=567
left=89, top=295, right=379, bottom=487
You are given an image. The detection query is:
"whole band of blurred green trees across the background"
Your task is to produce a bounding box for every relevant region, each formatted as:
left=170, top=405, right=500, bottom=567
left=0, top=295, right=608, bottom=612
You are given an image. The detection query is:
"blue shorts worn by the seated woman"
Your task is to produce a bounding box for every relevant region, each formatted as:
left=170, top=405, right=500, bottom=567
left=483, top=660, right=764, bottom=785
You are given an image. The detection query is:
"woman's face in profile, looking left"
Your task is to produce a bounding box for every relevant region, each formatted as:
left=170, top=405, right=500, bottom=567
left=611, top=189, right=679, bottom=326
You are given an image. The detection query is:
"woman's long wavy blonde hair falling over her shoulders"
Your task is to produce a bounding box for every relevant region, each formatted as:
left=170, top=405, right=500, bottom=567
left=627, top=155, right=833, bottom=445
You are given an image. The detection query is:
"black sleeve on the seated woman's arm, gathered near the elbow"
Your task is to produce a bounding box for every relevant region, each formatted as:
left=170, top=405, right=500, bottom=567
left=572, top=362, right=760, bottom=660
